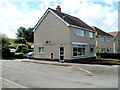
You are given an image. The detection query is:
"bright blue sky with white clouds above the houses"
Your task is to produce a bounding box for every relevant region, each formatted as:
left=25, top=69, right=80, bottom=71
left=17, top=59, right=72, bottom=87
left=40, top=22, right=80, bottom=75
left=0, top=0, right=119, bottom=38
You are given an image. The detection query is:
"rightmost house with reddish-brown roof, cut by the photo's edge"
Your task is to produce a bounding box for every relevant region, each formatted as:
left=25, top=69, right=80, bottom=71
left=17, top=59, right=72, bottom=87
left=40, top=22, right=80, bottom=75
left=108, top=31, right=120, bottom=53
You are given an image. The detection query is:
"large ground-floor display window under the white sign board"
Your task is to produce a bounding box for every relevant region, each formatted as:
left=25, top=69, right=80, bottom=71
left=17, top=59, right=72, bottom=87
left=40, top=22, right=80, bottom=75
left=73, top=44, right=86, bottom=56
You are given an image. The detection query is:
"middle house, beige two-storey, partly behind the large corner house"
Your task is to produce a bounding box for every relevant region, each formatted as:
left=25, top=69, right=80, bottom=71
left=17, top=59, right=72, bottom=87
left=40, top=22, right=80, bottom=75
left=93, top=26, right=114, bottom=53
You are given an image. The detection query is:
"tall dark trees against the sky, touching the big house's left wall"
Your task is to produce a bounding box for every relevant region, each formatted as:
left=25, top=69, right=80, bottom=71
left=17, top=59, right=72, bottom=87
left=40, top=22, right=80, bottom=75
left=16, top=27, right=34, bottom=42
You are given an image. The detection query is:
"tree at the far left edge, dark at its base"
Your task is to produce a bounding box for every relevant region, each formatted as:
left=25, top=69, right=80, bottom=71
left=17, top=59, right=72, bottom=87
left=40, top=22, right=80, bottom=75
left=0, top=34, right=10, bottom=57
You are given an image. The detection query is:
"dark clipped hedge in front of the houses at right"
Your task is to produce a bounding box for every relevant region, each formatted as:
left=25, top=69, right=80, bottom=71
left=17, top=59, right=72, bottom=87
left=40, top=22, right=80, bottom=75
left=97, top=53, right=120, bottom=59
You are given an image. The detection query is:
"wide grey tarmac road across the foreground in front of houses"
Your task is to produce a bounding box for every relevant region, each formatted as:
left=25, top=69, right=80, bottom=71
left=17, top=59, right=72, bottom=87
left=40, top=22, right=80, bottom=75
left=0, top=60, right=118, bottom=88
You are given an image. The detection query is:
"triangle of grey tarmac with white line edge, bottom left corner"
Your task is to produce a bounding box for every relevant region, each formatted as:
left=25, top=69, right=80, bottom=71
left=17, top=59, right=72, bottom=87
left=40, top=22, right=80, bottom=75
left=0, top=77, right=27, bottom=88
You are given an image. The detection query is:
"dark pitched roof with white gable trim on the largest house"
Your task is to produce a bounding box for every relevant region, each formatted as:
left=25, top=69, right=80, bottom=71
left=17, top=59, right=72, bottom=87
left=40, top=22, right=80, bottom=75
left=35, top=8, right=94, bottom=31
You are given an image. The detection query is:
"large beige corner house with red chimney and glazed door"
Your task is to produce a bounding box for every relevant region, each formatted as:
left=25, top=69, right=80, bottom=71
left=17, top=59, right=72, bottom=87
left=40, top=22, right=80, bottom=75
left=34, top=6, right=96, bottom=61
